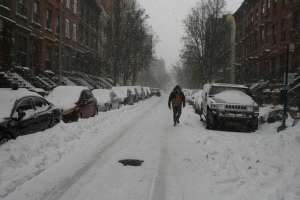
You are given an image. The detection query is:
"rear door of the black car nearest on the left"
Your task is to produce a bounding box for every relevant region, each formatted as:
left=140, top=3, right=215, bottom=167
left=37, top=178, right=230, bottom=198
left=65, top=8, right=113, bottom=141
left=33, top=97, right=53, bottom=131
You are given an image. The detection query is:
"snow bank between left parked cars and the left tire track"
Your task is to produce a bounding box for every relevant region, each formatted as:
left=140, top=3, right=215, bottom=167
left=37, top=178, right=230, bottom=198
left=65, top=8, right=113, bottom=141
left=0, top=98, right=162, bottom=200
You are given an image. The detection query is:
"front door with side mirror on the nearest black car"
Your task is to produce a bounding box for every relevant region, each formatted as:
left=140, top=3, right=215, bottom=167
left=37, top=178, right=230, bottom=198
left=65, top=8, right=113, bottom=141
left=12, top=97, right=37, bottom=135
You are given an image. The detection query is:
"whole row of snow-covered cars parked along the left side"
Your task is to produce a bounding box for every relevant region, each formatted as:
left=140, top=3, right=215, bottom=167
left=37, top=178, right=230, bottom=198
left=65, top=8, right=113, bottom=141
left=0, top=86, right=161, bottom=144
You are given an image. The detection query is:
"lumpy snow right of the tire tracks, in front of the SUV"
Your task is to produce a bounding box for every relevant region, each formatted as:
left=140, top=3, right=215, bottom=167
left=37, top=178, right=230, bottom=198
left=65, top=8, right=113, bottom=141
left=165, top=107, right=300, bottom=200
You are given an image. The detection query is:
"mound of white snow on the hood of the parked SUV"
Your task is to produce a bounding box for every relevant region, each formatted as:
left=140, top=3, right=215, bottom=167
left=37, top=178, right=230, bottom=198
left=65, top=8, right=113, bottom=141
left=215, top=90, right=254, bottom=105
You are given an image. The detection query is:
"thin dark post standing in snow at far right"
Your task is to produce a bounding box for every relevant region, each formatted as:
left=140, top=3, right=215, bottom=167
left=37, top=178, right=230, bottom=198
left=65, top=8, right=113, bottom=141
left=277, top=43, right=295, bottom=132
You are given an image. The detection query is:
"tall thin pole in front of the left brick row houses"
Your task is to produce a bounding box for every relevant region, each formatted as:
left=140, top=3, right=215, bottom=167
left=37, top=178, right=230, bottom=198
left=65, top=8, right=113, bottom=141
left=58, top=0, right=64, bottom=84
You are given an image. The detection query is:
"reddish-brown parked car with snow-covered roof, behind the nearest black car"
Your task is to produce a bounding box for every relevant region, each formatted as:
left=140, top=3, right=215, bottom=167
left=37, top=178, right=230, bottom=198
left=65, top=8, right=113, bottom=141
left=47, top=86, right=98, bottom=123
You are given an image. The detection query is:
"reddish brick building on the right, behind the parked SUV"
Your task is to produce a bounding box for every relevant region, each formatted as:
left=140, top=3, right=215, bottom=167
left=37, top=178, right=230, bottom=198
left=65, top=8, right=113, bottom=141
left=234, top=0, right=299, bottom=83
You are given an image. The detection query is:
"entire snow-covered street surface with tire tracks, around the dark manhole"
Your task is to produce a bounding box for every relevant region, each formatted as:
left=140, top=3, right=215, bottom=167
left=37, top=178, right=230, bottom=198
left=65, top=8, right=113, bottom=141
left=0, top=97, right=300, bottom=200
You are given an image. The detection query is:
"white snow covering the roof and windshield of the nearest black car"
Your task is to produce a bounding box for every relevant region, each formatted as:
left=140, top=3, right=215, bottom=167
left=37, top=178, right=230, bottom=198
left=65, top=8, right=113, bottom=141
left=0, top=88, right=42, bottom=121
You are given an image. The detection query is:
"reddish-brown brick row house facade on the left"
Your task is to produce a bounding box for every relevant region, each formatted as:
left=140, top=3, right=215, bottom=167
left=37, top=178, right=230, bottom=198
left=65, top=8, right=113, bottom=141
left=0, top=0, right=107, bottom=76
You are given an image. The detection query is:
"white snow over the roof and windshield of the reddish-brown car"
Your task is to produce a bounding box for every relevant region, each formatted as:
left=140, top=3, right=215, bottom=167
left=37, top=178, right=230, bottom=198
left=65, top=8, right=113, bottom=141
left=46, top=86, right=88, bottom=110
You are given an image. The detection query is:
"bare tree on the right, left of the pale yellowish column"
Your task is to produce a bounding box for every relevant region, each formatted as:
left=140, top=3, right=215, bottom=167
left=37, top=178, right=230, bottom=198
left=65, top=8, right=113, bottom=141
left=177, top=0, right=226, bottom=86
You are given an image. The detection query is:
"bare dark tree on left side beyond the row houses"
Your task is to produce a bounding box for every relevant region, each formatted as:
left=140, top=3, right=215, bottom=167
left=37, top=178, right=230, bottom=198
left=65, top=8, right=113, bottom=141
left=106, top=0, right=153, bottom=84
